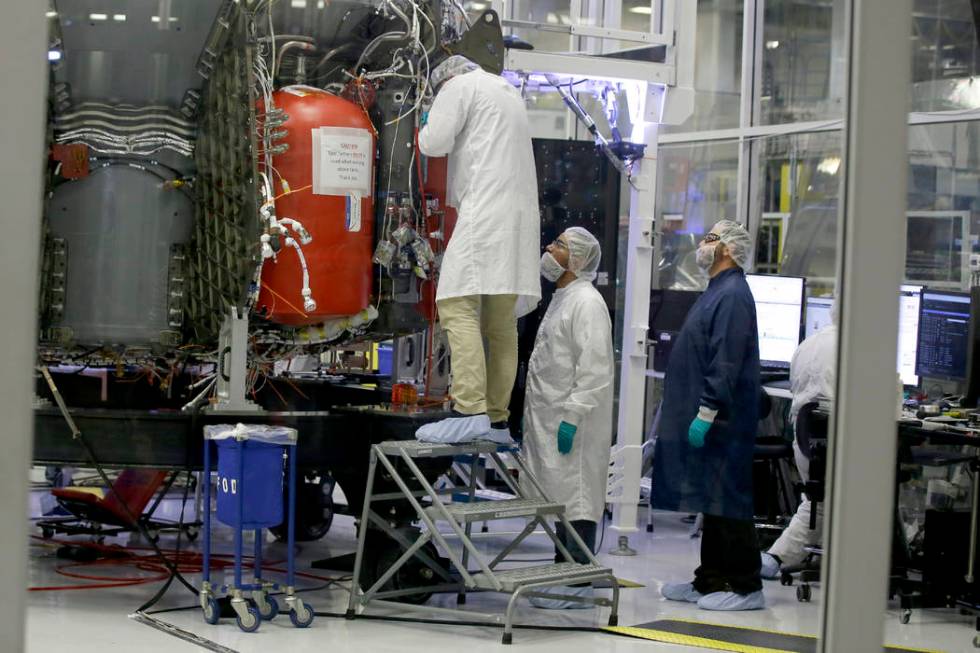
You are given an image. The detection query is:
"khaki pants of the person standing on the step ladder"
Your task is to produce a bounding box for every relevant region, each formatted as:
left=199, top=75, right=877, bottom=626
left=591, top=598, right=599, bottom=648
left=438, top=295, right=517, bottom=422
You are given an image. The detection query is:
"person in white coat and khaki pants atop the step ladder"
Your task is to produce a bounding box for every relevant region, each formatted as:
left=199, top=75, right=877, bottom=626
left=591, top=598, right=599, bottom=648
left=416, top=55, right=541, bottom=442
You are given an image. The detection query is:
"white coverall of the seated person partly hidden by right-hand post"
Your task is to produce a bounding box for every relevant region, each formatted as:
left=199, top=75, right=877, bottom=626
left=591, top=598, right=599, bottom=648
left=769, top=324, right=837, bottom=566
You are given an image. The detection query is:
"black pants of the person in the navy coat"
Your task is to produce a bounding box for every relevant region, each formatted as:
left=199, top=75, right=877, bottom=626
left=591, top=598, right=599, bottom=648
left=694, top=515, right=762, bottom=594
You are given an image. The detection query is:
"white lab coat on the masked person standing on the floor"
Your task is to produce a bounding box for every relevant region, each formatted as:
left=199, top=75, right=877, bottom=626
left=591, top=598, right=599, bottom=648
left=524, top=279, right=614, bottom=523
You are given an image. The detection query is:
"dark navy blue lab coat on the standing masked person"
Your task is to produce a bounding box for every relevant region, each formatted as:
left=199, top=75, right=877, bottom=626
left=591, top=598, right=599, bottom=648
left=653, top=268, right=761, bottom=520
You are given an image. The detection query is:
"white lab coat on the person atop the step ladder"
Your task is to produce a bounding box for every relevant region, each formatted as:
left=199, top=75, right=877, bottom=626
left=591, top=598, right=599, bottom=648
left=419, top=70, right=541, bottom=316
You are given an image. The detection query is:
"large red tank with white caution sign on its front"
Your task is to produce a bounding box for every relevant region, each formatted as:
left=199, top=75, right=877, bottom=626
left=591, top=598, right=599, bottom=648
left=255, top=86, right=375, bottom=326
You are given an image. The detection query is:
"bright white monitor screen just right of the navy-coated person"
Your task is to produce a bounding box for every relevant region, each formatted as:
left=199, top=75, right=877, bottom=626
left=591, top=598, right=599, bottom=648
left=745, top=274, right=806, bottom=369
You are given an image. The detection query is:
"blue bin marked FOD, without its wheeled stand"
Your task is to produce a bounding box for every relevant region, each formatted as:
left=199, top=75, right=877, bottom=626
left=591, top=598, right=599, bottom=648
left=215, top=438, right=284, bottom=530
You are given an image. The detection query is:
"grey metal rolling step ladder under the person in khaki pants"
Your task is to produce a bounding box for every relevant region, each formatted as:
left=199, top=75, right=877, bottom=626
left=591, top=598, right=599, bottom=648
left=347, top=440, right=619, bottom=644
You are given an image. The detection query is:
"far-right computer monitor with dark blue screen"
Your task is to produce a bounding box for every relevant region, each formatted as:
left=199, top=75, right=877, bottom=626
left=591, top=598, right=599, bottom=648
left=915, top=289, right=970, bottom=381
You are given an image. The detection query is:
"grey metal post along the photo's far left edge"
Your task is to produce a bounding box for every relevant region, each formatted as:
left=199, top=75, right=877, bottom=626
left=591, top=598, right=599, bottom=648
left=0, top=0, right=48, bottom=651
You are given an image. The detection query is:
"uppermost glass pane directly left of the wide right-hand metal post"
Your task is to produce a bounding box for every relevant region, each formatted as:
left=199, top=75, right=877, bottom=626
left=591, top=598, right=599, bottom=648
left=761, top=0, right=845, bottom=125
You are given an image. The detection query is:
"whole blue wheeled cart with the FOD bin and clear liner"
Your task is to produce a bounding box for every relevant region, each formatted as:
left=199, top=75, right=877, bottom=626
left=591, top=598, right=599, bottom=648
left=200, top=424, right=313, bottom=633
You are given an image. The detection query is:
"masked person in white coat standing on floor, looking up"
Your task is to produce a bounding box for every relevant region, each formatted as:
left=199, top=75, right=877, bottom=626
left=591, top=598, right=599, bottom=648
left=524, top=227, right=614, bottom=608
